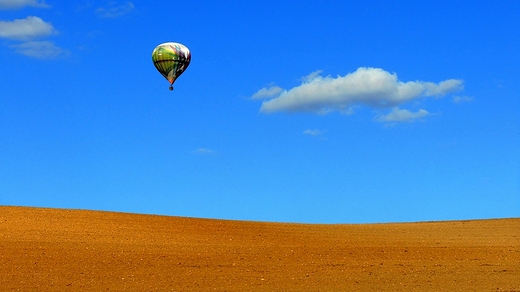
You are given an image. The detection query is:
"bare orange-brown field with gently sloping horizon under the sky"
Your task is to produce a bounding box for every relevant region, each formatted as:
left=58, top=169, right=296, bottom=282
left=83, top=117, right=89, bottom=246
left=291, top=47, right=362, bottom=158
left=0, top=207, right=520, bottom=291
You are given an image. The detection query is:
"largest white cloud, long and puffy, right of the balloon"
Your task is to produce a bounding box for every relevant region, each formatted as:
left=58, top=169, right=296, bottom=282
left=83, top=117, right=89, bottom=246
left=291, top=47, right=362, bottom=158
left=257, top=67, right=463, bottom=114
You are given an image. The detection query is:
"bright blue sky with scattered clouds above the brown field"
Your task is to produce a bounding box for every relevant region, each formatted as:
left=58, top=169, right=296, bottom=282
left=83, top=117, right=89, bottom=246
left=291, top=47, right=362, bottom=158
left=0, top=0, right=520, bottom=223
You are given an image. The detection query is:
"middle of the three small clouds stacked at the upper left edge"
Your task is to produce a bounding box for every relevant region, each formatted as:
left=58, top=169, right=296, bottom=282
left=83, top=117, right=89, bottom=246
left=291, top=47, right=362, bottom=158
left=0, top=16, right=57, bottom=40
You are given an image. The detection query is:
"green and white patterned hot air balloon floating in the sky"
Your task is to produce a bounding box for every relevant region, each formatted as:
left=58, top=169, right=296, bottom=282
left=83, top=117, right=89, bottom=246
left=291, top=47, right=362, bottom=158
left=152, top=42, right=191, bottom=90
